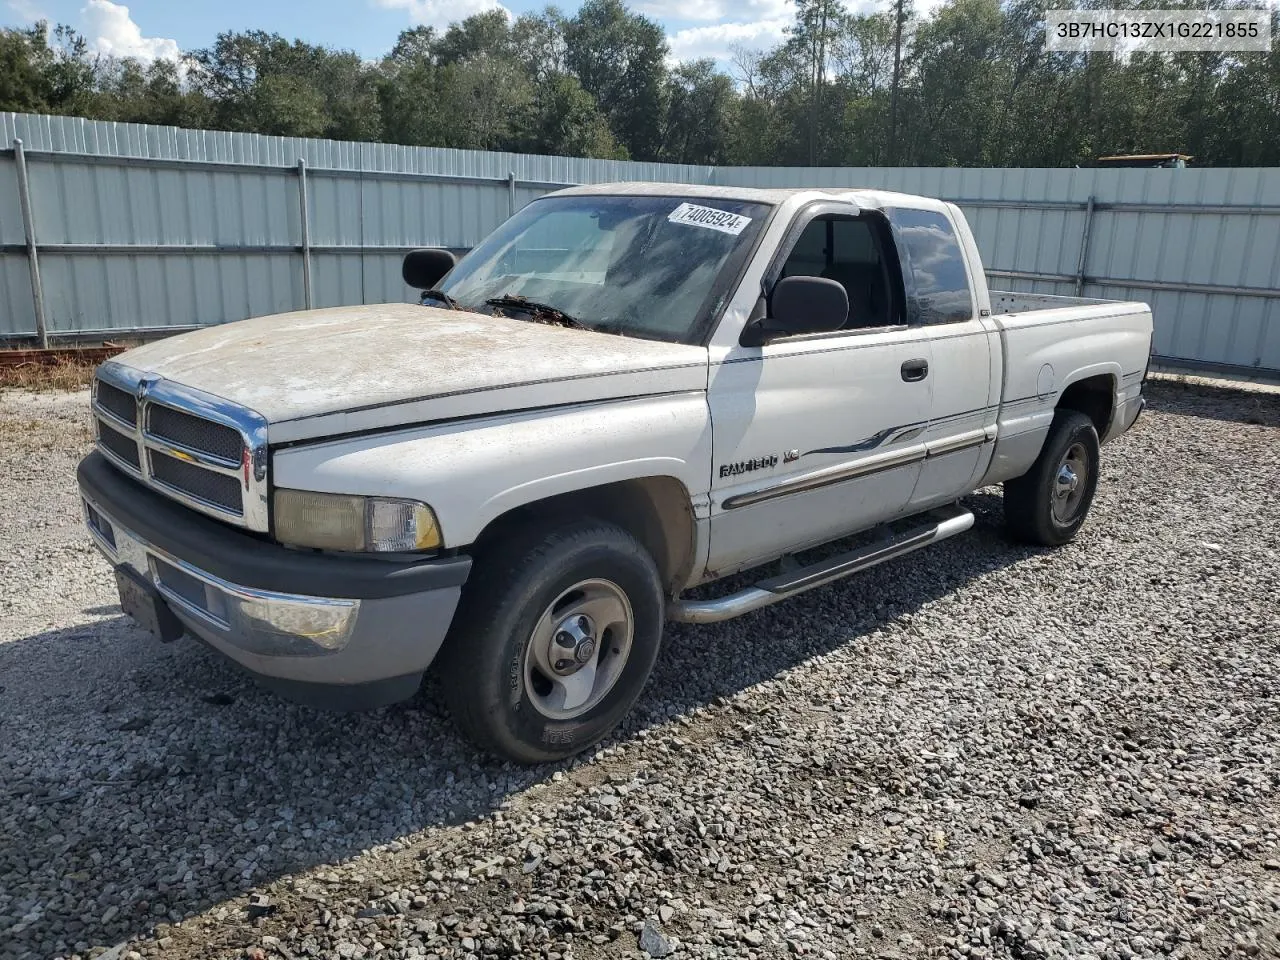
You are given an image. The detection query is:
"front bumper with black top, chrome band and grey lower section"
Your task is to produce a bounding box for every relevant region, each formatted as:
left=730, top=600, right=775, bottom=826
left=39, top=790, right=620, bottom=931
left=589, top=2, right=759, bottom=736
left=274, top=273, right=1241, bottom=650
left=77, top=453, right=471, bottom=709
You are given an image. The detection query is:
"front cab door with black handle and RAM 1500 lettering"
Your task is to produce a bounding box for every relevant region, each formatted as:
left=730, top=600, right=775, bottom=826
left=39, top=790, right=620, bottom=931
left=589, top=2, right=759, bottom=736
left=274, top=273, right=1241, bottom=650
left=708, top=201, right=933, bottom=573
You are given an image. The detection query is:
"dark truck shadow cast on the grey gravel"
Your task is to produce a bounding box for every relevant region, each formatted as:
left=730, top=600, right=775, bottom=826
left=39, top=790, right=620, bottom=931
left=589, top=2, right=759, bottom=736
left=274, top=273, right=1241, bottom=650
left=0, top=493, right=1038, bottom=956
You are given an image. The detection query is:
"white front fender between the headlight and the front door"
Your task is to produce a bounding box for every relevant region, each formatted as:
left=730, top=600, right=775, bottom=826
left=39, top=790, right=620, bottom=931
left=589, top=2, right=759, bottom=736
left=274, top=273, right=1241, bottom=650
left=271, top=392, right=712, bottom=548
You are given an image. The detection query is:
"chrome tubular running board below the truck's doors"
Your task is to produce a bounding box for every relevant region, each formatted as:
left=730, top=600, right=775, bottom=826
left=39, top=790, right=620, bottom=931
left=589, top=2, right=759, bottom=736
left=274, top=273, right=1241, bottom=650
left=667, top=507, right=973, bottom=623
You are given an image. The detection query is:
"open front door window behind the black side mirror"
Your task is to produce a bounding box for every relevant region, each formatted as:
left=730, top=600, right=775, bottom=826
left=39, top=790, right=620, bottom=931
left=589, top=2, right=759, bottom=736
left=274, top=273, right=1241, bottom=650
left=780, top=216, right=897, bottom=330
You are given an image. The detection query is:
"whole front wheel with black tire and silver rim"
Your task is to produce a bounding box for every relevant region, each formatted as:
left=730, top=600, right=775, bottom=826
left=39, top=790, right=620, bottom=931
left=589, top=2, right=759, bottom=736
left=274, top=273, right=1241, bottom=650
left=442, top=520, right=663, bottom=763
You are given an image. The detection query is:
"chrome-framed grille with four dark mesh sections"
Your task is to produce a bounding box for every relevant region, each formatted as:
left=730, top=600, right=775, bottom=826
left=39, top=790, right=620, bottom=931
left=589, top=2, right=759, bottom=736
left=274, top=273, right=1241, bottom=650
left=93, top=361, right=268, bottom=532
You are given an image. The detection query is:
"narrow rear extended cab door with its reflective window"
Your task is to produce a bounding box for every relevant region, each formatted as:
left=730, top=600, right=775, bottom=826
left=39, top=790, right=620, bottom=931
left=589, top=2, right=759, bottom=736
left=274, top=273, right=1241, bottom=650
left=884, top=205, right=1002, bottom=512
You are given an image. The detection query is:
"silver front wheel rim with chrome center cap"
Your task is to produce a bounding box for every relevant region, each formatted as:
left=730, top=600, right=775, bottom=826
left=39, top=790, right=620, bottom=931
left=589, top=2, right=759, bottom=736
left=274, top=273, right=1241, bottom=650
left=524, top=580, right=635, bottom=721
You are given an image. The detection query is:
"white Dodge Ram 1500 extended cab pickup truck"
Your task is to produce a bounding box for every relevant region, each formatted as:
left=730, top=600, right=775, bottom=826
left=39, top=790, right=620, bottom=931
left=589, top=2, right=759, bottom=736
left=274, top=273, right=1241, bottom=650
left=78, top=183, right=1152, bottom=763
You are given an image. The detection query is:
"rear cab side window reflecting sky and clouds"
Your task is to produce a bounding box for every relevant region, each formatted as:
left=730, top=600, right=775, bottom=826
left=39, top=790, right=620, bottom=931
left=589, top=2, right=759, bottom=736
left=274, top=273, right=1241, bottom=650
left=884, top=207, right=973, bottom=324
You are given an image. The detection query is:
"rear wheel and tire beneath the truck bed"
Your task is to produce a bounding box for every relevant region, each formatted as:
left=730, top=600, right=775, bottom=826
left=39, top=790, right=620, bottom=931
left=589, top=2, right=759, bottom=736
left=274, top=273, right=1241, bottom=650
left=1005, top=410, right=1101, bottom=547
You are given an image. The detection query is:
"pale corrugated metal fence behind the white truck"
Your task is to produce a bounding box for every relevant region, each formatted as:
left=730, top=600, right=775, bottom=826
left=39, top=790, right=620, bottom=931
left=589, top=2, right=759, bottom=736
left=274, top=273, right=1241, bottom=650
left=0, top=114, right=1280, bottom=371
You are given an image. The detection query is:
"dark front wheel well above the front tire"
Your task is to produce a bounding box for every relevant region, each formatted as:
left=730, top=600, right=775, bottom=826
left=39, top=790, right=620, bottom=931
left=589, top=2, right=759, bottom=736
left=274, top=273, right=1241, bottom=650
left=474, top=476, right=695, bottom=591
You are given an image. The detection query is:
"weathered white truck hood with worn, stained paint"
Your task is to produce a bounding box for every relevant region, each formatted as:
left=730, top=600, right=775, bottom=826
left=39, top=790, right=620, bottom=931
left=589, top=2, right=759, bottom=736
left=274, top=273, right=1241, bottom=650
left=116, top=303, right=707, bottom=443
